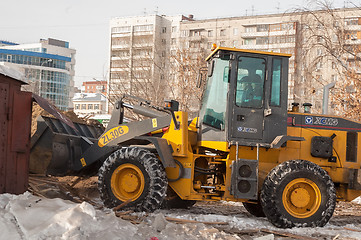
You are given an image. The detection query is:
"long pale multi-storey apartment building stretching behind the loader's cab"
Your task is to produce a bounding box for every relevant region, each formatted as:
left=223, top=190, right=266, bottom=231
left=109, top=8, right=361, bottom=113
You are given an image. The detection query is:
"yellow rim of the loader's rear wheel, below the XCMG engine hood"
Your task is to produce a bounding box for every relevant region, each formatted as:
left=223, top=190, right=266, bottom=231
left=282, top=178, right=321, bottom=218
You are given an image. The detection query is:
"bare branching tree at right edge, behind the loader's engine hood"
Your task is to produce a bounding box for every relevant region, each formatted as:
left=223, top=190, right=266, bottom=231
left=298, top=0, right=361, bottom=120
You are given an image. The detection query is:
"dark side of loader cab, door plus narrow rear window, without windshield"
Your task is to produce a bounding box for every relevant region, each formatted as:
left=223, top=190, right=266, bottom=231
left=228, top=53, right=288, bottom=146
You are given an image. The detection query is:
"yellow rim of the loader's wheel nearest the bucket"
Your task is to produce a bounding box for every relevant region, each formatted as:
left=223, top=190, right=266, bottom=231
left=110, top=163, right=145, bottom=202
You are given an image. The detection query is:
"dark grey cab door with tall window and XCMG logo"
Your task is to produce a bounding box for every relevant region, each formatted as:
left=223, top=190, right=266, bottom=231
left=229, top=55, right=267, bottom=140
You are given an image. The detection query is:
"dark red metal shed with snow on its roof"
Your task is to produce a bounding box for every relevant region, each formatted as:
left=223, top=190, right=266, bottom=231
left=0, top=65, right=32, bottom=194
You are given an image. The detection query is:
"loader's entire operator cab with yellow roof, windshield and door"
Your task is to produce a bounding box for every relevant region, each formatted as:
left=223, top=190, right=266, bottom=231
left=199, top=47, right=291, bottom=147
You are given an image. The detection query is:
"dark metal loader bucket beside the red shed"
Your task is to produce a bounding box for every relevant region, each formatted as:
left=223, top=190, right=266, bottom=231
left=29, top=116, right=104, bottom=176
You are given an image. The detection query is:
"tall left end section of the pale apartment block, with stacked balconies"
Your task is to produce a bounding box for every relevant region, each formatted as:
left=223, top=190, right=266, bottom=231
left=108, top=15, right=191, bottom=109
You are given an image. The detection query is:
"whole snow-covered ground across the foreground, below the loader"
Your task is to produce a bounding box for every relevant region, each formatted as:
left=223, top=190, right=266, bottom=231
left=0, top=192, right=361, bottom=240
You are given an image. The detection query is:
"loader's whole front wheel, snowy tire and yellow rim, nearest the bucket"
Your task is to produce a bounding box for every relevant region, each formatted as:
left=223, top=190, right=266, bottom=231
left=98, top=147, right=168, bottom=212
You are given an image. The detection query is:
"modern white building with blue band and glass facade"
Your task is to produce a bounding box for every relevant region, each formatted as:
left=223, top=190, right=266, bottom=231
left=0, top=38, right=76, bottom=110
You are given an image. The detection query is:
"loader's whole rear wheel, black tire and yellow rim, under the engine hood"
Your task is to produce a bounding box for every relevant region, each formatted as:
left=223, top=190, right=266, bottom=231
left=261, top=160, right=336, bottom=228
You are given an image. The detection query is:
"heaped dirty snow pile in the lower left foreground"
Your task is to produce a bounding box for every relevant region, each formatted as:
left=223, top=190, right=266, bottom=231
left=0, top=193, right=240, bottom=240
